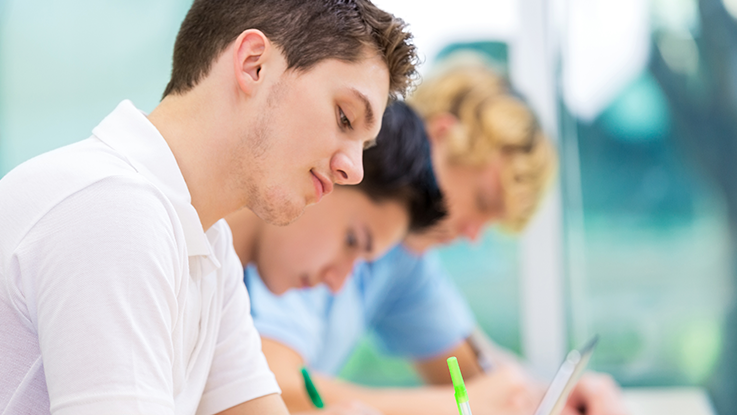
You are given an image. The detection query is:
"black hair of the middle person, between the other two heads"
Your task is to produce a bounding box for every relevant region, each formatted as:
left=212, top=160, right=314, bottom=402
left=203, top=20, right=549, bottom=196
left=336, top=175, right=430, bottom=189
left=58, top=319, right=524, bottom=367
left=356, top=101, right=447, bottom=232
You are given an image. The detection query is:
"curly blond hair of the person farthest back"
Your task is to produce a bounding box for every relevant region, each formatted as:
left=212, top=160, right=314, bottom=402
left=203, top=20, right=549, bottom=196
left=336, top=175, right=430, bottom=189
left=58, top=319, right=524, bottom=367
left=408, top=56, right=557, bottom=232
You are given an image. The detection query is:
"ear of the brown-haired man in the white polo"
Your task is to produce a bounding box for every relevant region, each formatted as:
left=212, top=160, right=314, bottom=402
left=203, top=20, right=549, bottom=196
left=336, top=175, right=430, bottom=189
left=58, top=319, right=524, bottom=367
left=233, top=29, right=273, bottom=95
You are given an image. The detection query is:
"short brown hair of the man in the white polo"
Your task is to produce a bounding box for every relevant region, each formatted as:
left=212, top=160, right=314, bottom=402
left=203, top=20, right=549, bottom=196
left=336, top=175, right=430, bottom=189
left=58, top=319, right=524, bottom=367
left=164, top=0, right=418, bottom=97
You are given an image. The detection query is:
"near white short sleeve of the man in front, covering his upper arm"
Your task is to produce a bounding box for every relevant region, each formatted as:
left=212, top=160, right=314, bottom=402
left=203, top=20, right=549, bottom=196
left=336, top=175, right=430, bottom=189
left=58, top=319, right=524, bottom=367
left=24, top=177, right=183, bottom=415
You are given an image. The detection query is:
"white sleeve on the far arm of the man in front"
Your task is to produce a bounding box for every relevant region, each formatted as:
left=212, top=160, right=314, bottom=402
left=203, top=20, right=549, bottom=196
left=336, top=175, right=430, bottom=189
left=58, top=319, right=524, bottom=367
left=197, top=222, right=281, bottom=415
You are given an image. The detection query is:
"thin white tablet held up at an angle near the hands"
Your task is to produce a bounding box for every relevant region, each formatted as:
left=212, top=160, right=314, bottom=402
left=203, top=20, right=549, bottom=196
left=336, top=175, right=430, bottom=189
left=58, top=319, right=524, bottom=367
left=535, top=336, right=599, bottom=415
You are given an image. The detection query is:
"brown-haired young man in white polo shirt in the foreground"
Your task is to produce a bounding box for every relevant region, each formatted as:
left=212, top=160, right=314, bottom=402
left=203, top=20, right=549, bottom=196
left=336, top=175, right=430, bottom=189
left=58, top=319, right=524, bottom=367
left=0, top=0, right=415, bottom=414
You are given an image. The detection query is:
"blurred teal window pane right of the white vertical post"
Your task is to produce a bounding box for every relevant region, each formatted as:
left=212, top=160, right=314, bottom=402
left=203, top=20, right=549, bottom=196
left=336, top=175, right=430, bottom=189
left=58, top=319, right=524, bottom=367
left=560, top=0, right=737, bottom=414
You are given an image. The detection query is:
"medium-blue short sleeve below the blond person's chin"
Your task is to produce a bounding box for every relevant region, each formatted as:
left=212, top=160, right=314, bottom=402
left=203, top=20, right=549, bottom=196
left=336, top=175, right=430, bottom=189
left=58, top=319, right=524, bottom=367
left=364, top=246, right=476, bottom=359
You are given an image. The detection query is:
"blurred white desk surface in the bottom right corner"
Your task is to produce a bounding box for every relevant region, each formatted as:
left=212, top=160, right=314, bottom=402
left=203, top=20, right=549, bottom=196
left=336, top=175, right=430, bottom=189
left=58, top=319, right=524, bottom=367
left=624, top=388, right=716, bottom=415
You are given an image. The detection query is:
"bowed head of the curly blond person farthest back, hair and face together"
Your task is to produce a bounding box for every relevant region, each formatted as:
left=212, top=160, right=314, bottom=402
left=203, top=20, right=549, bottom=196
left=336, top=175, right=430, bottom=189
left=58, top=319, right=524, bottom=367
left=409, top=60, right=557, bottom=251
